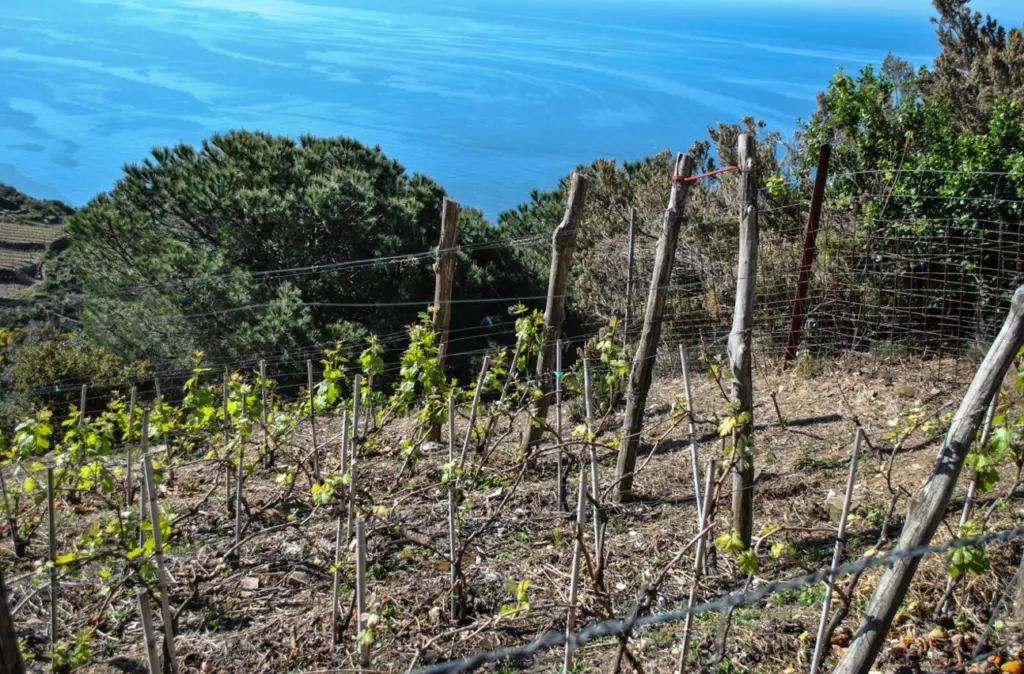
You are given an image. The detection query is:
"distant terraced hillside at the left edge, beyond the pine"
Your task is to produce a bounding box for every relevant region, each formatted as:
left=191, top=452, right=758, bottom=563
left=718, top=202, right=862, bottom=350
left=0, top=182, right=75, bottom=298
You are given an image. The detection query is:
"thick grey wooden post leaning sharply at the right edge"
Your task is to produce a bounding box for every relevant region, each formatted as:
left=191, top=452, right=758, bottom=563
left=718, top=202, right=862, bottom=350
left=836, top=286, right=1024, bottom=674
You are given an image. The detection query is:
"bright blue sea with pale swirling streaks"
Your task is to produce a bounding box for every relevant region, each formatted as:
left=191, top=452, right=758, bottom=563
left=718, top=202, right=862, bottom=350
left=0, top=0, right=1024, bottom=217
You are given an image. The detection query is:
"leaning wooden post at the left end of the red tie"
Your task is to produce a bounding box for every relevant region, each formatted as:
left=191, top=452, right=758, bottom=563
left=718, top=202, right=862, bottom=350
left=614, top=154, right=693, bottom=503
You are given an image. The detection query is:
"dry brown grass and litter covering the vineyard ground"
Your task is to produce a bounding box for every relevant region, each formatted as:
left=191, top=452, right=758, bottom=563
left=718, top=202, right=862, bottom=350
left=4, top=356, right=1022, bottom=673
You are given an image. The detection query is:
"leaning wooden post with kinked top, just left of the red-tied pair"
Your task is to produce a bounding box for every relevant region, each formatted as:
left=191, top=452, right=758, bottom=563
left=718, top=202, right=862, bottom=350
left=522, top=172, right=587, bottom=456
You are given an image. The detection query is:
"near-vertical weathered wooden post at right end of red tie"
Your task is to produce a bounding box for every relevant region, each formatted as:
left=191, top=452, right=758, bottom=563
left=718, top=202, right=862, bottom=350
left=729, top=133, right=758, bottom=548
